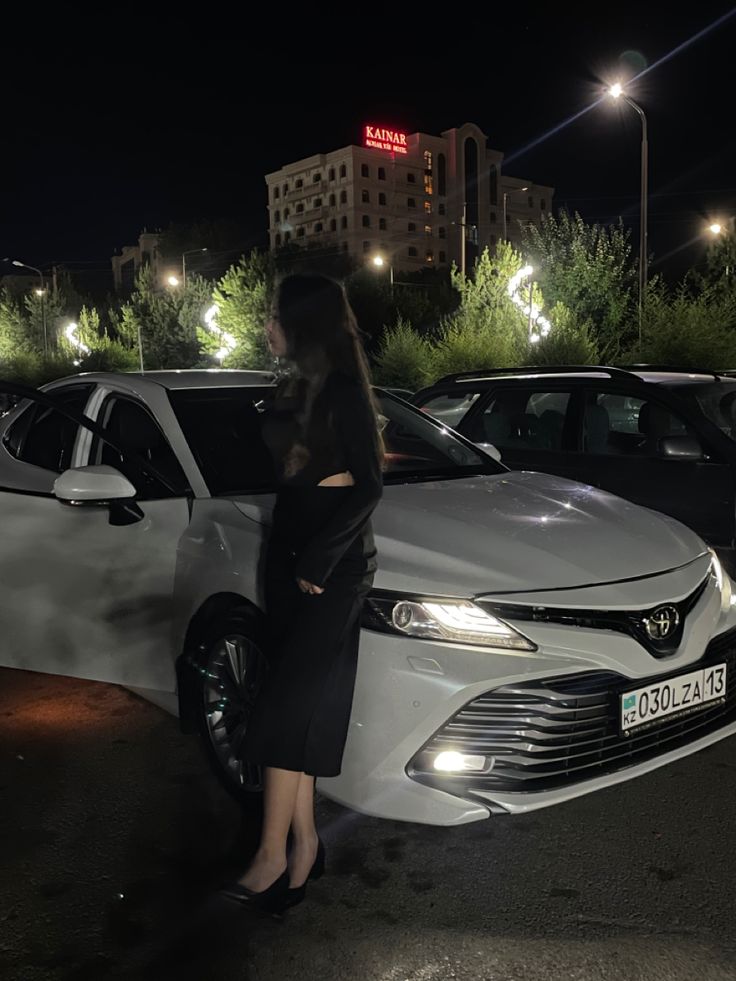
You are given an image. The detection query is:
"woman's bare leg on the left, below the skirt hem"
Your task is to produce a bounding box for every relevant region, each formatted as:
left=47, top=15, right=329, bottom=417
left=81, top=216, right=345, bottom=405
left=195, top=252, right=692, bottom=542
left=240, top=766, right=304, bottom=892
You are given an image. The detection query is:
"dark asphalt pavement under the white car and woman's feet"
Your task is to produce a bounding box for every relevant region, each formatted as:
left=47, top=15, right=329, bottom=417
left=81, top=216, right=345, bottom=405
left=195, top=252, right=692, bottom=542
left=0, top=670, right=736, bottom=981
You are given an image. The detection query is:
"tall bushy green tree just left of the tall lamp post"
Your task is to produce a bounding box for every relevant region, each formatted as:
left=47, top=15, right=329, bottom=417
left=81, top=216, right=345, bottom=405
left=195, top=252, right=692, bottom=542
left=522, top=211, right=637, bottom=360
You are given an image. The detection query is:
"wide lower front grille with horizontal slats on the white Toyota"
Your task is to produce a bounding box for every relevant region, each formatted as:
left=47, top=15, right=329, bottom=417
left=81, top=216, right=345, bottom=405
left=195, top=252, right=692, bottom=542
left=407, top=630, right=736, bottom=794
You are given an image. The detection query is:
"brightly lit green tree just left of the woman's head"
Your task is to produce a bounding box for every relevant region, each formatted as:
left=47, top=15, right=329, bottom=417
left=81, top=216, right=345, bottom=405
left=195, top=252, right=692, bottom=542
left=211, top=249, right=274, bottom=369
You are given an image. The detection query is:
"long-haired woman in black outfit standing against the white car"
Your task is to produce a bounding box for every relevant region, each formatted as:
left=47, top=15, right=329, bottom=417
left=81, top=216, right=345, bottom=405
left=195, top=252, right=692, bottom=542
left=224, top=275, right=383, bottom=912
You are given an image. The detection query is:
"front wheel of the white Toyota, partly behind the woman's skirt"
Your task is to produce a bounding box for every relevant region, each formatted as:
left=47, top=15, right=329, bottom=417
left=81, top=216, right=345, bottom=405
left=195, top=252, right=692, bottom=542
left=195, top=609, right=266, bottom=803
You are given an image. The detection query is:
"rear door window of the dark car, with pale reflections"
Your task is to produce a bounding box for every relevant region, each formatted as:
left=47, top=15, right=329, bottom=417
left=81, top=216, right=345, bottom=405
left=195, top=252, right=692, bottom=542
left=471, top=388, right=570, bottom=452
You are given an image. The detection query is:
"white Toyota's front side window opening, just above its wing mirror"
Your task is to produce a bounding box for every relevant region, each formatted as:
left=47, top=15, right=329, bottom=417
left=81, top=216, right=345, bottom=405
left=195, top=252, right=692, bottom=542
left=90, top=396, right=188, bottom=501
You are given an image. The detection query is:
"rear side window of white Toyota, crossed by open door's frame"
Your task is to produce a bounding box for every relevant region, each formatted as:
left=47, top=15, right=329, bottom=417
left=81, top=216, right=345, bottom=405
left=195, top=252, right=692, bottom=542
left=4, top=385, right=92, bottom=473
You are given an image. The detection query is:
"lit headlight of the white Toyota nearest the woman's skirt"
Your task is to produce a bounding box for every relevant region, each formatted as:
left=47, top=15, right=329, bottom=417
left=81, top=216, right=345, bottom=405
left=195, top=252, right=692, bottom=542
left=363, top=594, right=537, bottom=651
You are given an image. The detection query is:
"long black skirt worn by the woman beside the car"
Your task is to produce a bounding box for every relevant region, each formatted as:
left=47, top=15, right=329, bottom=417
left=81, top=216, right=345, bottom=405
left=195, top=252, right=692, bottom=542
left=243, top=487, right=376, bottom=777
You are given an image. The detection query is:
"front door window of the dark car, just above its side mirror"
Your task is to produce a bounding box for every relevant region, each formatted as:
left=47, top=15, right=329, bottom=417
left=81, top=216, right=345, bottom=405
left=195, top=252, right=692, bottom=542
left=583, top=392, right=697, bottom=457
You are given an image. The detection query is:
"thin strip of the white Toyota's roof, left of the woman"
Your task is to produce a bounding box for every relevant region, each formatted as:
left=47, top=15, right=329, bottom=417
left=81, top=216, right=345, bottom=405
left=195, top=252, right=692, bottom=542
left=44, top=368, right=276, bottom=396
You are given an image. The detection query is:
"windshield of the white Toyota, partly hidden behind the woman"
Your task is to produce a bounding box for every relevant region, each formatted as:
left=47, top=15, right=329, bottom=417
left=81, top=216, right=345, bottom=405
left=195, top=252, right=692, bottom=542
left=169, top=387, right=506, bottom=497
